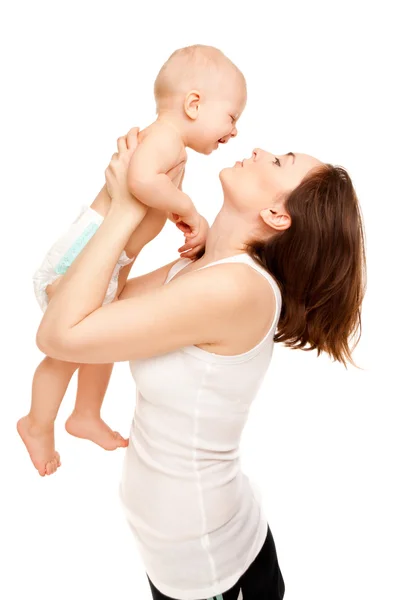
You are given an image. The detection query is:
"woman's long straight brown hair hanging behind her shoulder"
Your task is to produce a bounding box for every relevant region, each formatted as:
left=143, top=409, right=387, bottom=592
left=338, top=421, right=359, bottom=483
left=247, top=164, right=366, bottom=366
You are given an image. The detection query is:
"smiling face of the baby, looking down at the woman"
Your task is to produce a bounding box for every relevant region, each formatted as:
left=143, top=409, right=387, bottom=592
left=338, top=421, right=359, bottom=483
left=190, top=80, right=247, bottom=154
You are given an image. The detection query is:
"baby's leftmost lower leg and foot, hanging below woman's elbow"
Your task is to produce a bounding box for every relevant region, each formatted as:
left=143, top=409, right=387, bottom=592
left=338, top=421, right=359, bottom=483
left=17, top=356, right=79, bottom=477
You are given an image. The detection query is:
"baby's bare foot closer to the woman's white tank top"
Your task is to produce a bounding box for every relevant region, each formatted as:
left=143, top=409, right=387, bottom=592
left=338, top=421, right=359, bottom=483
left=65, top=412, right=128, bottom=450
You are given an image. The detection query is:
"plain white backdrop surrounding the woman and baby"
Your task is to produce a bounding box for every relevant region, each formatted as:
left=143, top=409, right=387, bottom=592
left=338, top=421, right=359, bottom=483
left=0, top=0, right=400, bottom=600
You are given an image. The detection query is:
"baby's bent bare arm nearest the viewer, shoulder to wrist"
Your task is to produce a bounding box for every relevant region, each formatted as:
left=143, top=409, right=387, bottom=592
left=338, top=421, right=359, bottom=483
left=128, top=128, right=198, bottom=220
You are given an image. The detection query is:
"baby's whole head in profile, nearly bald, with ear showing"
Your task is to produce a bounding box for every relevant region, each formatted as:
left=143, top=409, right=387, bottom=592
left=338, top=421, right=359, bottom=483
left=154, top=45, right=247, bottom=154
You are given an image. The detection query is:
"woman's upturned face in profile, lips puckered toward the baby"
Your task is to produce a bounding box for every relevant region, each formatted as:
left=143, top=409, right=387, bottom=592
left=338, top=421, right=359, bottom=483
left=220, top=148, right=322, bottom=211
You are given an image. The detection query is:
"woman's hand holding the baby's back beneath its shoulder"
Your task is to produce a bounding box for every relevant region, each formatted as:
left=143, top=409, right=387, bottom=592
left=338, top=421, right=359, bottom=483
left=105, top=127, right=147, bottom=212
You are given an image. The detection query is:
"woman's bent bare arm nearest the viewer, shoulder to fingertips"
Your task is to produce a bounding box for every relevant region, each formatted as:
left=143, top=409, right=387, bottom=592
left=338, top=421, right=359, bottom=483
left=37, top=130, right=252, bottom=363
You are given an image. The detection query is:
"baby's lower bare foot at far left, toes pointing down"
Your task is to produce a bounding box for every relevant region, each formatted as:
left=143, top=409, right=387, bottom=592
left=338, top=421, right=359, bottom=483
left=17, top=415, right=61, bottom=477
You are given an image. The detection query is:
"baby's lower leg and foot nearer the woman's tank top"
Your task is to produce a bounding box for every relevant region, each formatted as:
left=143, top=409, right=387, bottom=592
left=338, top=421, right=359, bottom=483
left=65, top=363, right=128, bottom=450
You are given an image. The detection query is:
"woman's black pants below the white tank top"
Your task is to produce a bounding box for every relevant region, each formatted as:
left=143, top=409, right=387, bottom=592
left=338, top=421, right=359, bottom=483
left=147, top=527, right=285, bottom=600
